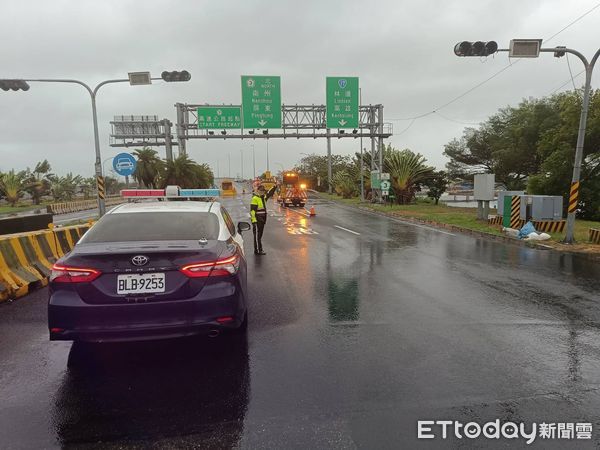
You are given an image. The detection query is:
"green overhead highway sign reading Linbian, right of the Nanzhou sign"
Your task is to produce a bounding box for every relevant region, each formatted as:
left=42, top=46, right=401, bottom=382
left=326, top=77, right=359, bottom=128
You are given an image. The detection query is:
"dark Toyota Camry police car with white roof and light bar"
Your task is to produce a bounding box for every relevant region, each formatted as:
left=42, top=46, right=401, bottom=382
left=48, top=188, right=250, bottom=342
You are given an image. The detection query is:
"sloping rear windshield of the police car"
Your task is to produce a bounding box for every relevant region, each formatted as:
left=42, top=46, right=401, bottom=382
left=81, top=211, right=219, bottom=243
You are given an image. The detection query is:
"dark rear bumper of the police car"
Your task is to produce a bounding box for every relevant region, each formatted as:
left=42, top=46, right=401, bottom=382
left=48, top=285, right=246, bottom=342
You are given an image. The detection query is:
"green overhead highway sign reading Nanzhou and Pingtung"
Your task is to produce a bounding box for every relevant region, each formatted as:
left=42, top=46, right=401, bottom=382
left=242, top=75, right=281, bottom=128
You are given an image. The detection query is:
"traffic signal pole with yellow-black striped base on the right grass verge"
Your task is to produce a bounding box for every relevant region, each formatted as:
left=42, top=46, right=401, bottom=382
left=454, top=39, right=600, bottom=244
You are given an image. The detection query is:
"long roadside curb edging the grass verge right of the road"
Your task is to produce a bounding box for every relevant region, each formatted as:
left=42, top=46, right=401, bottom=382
left=316, top=193, right=600, bottom=261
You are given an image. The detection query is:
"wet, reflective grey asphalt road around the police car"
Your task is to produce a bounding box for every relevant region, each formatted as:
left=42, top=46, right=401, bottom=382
left=0, top=195, right=600, bottom=449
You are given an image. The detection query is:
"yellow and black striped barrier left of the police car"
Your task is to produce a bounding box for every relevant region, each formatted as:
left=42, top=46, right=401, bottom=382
left=0, top=223, right=91, bottom=302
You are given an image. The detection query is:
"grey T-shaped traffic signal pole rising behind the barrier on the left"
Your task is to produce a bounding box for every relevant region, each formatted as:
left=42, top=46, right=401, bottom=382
left=0, top=70, right=191, bottom=217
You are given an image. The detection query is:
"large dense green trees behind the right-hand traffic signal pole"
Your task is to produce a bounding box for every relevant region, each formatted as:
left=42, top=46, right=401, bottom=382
left=444, top=90, right=600, bottom=220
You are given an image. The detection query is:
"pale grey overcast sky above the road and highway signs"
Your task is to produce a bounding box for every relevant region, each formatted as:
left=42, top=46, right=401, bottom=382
left=0, top=0, right=600, bottom=177
